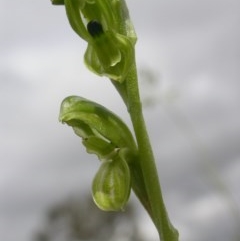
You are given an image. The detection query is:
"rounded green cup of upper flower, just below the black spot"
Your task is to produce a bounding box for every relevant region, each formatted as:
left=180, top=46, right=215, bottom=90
left=84, top=31, right=134, bottom=82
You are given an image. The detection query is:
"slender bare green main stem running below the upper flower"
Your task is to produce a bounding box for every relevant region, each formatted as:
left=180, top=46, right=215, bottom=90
left=125, top=58, right=178, bottom=241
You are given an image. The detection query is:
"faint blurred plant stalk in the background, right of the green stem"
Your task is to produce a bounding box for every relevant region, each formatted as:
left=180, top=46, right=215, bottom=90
left=139, top=67, right=240, bottom=241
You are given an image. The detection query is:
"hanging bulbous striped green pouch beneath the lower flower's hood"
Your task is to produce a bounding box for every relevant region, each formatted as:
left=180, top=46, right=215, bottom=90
left=92, top=156, right=131, bottom=211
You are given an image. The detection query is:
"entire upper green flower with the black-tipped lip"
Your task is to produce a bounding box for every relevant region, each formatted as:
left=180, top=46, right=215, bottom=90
left=60, top=0, right=137, bottom=82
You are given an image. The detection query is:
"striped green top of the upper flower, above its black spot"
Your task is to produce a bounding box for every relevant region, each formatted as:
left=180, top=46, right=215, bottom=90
left=63, top=0, right=137, bottom=41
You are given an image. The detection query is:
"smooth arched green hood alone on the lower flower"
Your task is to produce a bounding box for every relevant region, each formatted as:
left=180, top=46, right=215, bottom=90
left=59, top=96, right=137, bottom=152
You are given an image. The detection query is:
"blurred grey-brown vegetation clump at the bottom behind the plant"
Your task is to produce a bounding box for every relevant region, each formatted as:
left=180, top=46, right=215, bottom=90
left=33, top=195, right=143, bottom=241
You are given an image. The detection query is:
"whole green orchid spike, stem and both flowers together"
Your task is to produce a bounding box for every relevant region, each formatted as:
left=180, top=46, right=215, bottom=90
left=52, top=0, right=178, bottom=241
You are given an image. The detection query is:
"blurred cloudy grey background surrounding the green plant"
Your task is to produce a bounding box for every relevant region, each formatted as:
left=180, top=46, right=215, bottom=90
left=0, top=0, right=240, bottom=241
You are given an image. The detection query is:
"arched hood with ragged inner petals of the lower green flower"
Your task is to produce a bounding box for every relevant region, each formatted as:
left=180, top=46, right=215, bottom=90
left=59, top=96, right=137, bottom=160
